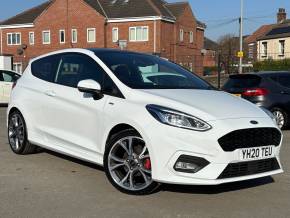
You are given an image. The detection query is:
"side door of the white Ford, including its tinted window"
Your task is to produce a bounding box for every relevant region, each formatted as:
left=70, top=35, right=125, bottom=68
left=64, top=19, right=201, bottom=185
left=43, top=53, right=112, bottom=154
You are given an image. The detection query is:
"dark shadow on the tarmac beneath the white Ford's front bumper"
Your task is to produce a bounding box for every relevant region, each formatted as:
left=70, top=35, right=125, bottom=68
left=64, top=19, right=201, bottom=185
left=161, top=176, right=275, bottom=194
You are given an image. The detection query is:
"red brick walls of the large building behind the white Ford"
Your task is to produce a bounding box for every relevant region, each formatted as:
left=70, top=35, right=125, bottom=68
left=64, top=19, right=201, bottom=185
left=3, top=0, right=204, bottom=74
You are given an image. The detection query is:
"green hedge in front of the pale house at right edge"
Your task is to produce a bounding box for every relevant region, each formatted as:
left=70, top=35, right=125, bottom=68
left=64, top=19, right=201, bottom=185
left=254, top=59, right=290, bottom=71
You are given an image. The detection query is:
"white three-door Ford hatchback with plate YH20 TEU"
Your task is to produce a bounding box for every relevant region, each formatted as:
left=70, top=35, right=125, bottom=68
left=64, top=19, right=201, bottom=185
left=7, top=49, right=283, bottom=194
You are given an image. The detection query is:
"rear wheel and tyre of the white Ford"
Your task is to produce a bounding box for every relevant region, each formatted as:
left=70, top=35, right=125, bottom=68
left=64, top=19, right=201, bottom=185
left=8, top=111, right=37, bottom=155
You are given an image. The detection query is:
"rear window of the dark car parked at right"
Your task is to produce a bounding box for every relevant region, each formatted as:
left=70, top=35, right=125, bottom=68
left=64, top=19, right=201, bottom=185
left=224, top=75, right=261, bottom=90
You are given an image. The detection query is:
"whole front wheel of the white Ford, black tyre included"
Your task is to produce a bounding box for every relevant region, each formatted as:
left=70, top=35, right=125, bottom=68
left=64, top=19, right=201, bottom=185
left=104, top=130, right=159, bottom=195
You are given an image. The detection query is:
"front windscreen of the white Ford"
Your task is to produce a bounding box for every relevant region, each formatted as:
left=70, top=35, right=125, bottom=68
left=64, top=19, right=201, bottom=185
left=96, top=52, right=214, bottom=89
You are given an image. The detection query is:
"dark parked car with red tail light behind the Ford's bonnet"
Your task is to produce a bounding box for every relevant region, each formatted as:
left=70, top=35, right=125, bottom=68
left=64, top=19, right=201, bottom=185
left=223, top=72, right=290, bottom=129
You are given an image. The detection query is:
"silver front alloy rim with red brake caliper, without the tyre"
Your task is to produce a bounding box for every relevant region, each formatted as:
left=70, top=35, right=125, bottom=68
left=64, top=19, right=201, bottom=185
left=108, top=136, right=153, bottom=191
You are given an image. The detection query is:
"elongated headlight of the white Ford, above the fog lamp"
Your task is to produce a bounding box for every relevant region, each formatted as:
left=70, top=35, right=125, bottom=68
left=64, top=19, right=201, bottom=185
left=146, top=105, right=212, bottom=131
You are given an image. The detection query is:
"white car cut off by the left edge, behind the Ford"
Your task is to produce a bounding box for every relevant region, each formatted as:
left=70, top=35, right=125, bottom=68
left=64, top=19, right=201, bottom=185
left=0, top=70, right=21, bottom=104
